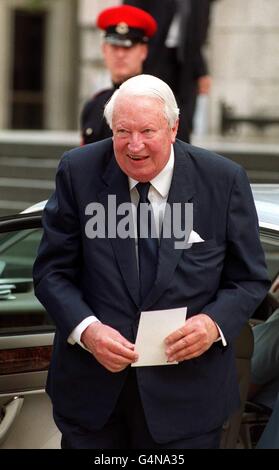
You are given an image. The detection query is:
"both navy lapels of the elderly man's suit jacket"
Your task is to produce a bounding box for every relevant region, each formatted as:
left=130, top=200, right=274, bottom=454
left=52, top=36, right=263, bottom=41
left=98, top=141, right=197, bottom=310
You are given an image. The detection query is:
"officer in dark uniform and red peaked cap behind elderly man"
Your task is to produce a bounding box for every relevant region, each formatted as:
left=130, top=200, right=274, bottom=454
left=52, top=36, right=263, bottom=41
left=81, top=5, right=157, bottom=144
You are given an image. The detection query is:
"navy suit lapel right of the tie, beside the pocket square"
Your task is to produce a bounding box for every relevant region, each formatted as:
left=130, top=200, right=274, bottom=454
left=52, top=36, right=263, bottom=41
left=141, top=141, right=194, bottom=310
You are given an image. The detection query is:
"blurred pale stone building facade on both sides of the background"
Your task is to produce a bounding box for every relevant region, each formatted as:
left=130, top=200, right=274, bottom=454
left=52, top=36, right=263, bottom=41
left=0, top=0, right=279, bottom=137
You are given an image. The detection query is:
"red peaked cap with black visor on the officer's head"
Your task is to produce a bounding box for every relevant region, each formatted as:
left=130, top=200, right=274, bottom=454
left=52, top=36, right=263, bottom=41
left=97, top=5, right=157, bottom=47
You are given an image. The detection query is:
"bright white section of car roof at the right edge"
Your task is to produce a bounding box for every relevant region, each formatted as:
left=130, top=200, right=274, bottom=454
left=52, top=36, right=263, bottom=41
left=251, top=184, right=279, bottom=231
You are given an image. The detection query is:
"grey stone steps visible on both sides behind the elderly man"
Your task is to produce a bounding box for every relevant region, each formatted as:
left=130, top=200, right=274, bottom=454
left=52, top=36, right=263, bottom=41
left=0, top=131, right=279, bottom=219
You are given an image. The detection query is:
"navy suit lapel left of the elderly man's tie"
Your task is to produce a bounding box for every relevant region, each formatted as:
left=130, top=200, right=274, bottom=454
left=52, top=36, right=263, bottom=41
left=98, top=155, right=139, bottom=306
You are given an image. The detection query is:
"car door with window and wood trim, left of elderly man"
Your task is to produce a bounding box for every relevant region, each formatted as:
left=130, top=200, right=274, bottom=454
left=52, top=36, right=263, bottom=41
left=0, top=213, right=60, bottom=449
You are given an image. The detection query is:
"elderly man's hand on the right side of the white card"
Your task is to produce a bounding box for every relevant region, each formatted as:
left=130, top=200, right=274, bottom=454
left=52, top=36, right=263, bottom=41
left=165, top=313, right=219, bottom=362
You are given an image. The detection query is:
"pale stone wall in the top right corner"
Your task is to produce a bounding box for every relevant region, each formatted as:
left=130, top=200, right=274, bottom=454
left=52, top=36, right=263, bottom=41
left=208, top=0, right=279, bottom=136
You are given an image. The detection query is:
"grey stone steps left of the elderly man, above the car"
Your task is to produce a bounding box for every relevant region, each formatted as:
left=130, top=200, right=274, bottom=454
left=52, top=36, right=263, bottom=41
left=0, top=131, right=76, bottom=216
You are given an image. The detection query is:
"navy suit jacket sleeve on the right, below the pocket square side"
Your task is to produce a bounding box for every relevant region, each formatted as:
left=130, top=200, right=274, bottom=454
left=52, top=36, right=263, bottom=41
left=203, top=167, right=270, bottom=341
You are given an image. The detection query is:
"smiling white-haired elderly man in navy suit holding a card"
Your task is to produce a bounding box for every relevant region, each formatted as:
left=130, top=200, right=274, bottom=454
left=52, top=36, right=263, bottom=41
left=34, top=75, right=269, bottom=449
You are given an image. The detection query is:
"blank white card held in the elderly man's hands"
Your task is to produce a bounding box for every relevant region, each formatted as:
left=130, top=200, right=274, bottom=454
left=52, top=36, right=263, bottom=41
left=132, top=307, right=187, bottom=367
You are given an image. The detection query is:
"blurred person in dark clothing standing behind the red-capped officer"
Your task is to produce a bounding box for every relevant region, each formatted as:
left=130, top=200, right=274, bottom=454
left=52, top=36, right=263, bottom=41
left=123, top=0, right=218, bottom=142
